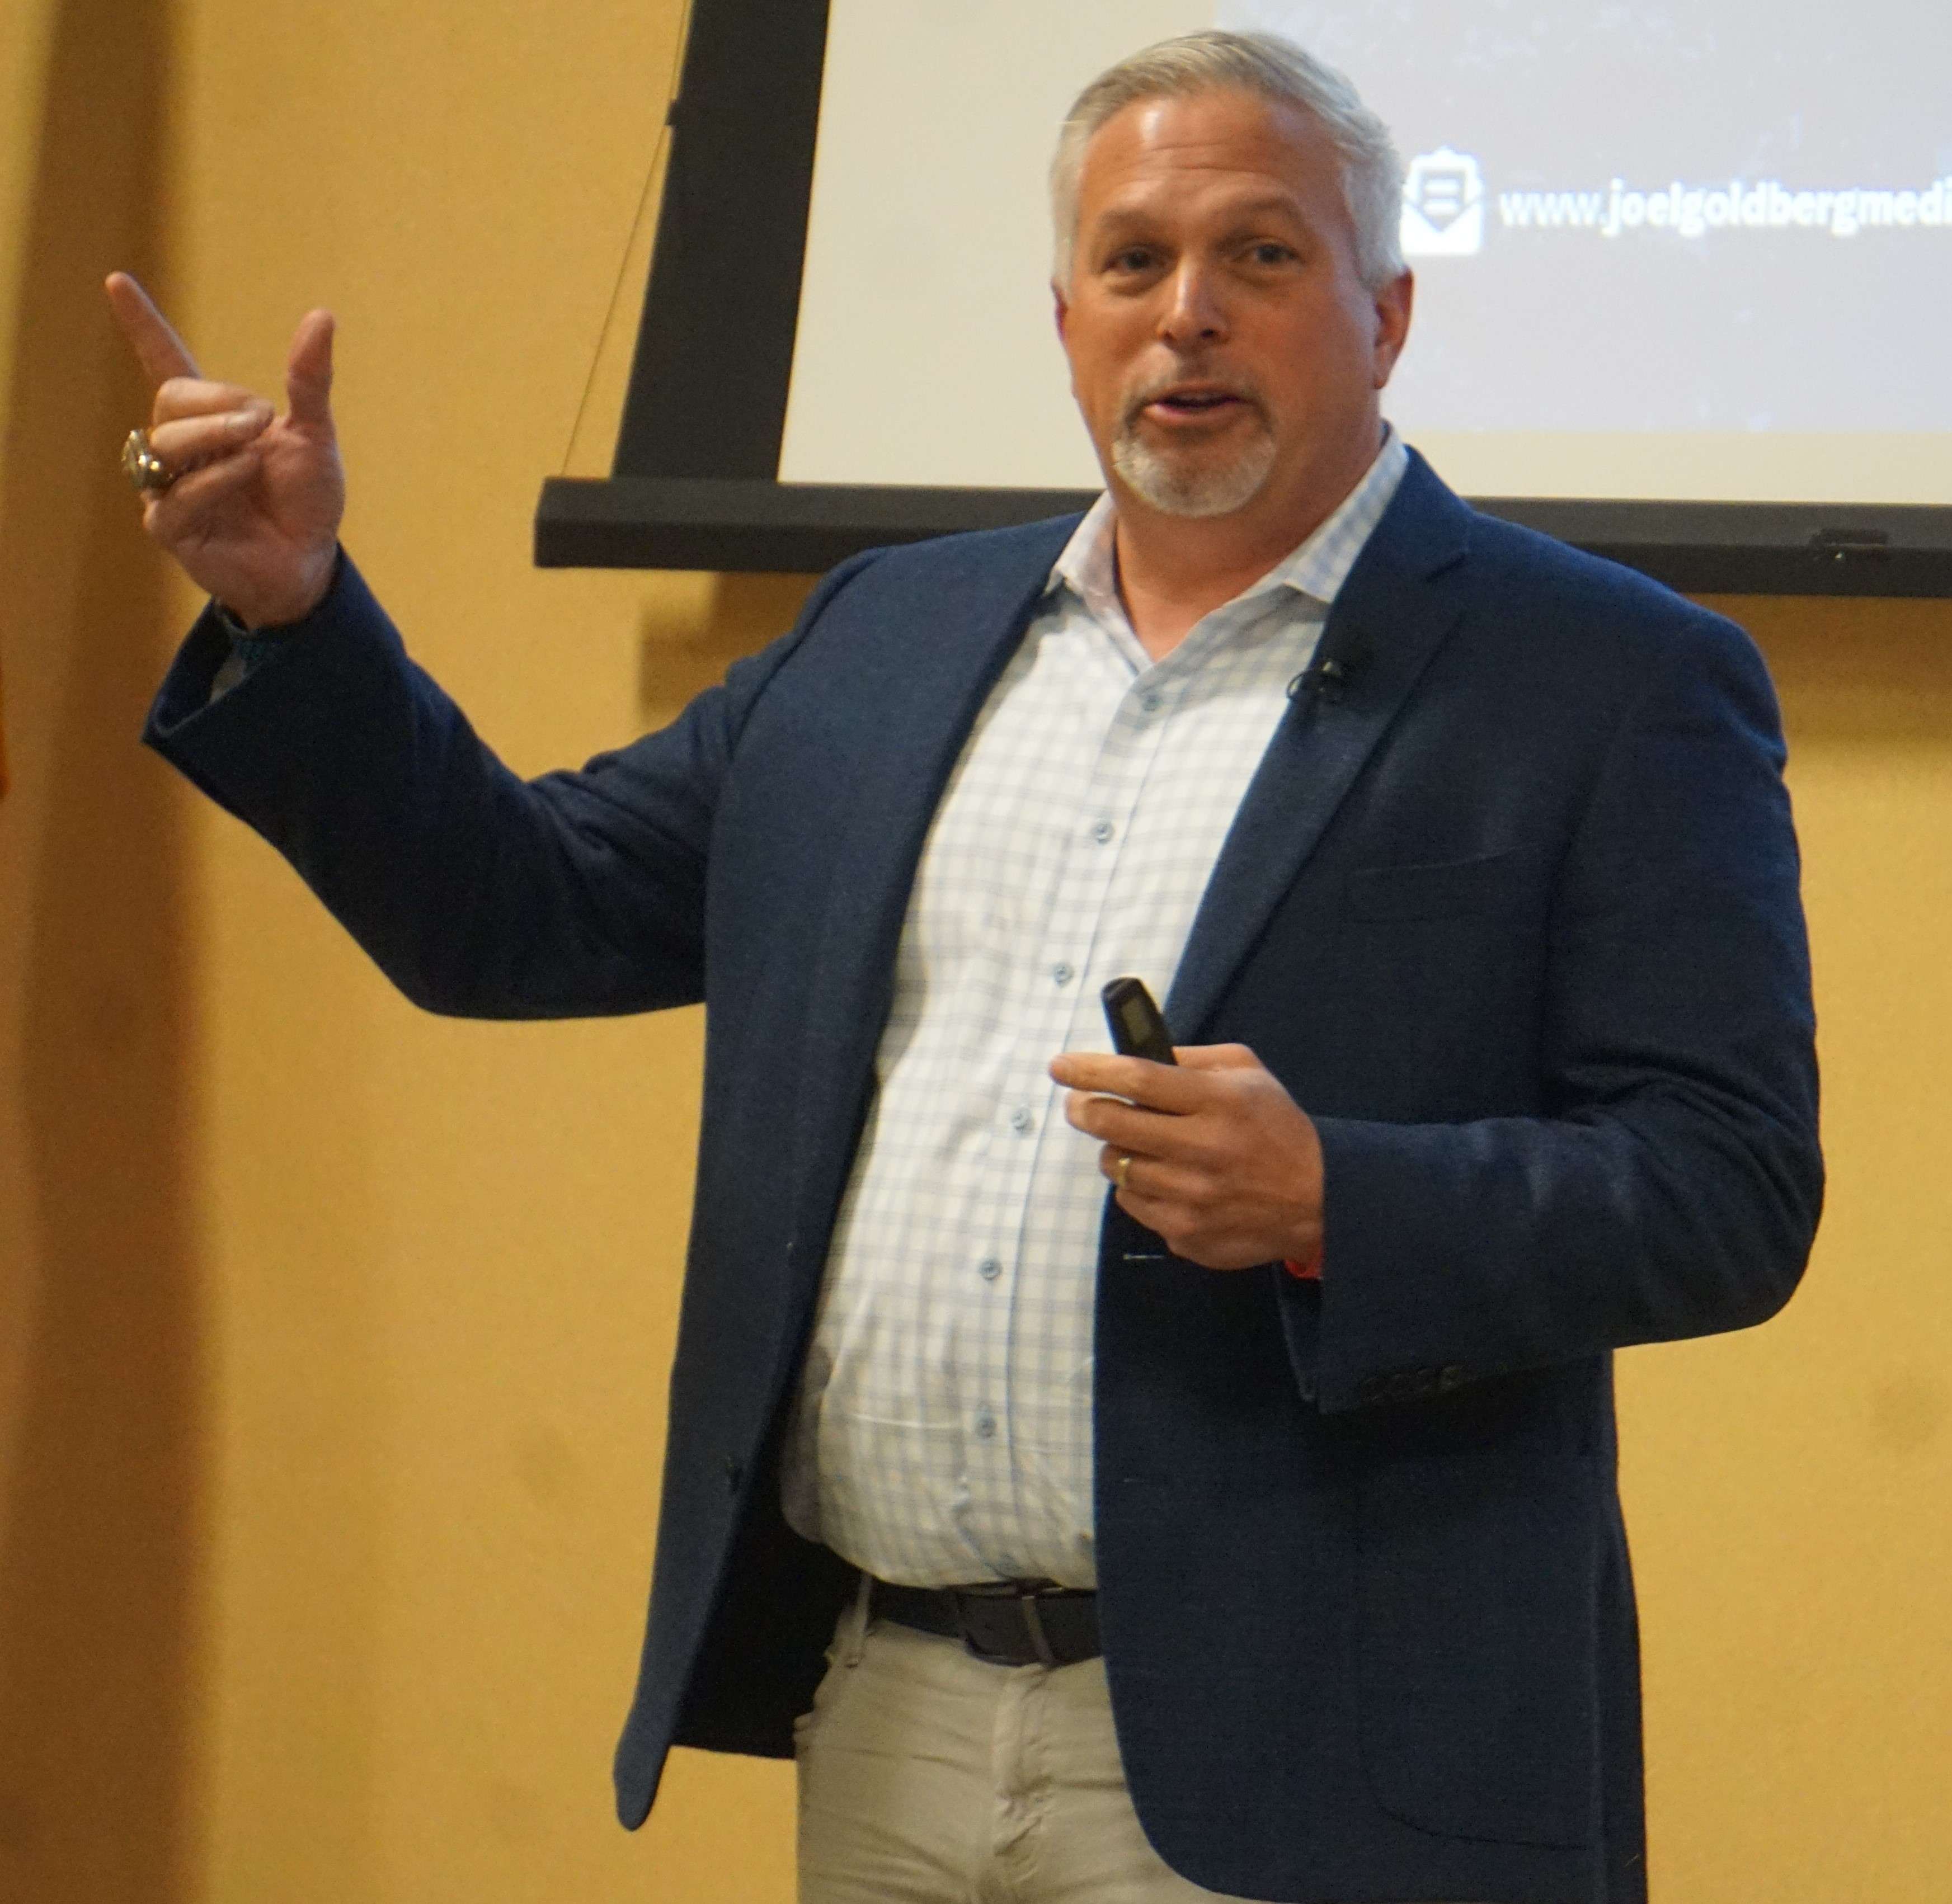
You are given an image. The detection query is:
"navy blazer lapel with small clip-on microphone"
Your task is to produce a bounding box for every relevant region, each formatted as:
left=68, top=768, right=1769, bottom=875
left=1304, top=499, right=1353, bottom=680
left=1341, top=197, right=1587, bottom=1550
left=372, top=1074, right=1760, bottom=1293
left=1165, top=451, right=1470, bottom=1044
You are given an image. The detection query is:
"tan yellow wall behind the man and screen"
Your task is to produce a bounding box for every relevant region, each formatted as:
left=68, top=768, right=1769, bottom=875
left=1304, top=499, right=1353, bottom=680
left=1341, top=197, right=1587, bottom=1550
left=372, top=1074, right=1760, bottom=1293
left=0, top=0, right=1952, bottom=1904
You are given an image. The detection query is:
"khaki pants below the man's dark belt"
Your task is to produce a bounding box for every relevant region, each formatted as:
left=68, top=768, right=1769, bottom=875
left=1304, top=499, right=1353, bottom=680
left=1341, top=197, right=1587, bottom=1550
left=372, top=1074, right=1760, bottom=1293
left=797, top=1601, right=1264, bottom=1904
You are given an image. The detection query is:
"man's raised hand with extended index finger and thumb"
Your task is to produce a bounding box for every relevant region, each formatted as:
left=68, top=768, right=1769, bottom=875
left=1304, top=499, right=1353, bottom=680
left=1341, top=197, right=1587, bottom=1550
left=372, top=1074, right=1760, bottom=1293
left=107, top=271, right=346, bottom=628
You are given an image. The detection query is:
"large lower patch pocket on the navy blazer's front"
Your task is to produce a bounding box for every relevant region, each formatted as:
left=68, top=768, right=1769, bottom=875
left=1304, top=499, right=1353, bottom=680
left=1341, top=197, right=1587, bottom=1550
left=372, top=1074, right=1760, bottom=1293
left=1357, top=1453, right=1602, bottom=1845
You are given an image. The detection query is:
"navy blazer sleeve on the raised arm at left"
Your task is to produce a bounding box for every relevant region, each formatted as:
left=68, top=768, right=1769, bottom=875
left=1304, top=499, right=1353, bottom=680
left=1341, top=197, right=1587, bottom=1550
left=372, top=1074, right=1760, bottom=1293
left=143, top=556, right=871, bottom=1019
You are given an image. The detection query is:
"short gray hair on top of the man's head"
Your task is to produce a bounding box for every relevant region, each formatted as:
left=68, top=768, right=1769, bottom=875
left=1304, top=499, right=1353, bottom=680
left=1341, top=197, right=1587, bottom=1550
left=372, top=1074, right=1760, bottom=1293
left=1050, top=27, right=1404, bottom=291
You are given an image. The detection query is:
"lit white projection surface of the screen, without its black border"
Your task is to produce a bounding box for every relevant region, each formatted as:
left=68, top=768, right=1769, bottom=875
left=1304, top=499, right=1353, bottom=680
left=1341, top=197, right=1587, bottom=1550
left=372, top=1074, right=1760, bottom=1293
left=779, top=0, right=1952, bottom=505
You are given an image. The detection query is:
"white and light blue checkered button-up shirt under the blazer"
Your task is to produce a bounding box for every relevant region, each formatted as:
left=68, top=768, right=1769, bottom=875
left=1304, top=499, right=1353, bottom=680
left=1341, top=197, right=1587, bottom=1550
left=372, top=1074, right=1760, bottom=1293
left=783, top=431, right=1408, bottom=1586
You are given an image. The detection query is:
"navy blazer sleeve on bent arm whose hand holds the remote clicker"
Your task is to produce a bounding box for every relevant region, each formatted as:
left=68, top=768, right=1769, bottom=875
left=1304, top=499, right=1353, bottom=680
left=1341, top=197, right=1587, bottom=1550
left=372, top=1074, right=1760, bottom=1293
left=1282, top=615, right=1823, bottom=1411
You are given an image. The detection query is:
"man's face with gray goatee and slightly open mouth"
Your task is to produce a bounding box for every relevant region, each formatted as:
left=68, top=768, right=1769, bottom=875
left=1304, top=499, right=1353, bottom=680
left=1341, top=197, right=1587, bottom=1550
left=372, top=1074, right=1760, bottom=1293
left=1056, top=89, right=1409, bottom=535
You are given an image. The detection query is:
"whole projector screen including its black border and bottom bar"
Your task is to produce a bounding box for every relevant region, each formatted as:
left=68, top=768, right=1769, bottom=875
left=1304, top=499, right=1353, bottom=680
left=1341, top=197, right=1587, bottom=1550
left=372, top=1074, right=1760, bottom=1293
left=535, top=0, right=1952, bottom=595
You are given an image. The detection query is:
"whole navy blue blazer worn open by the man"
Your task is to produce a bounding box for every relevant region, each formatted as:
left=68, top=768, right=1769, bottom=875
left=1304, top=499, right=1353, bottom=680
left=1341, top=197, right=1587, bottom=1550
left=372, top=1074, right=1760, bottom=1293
left=147, top=460, right=1821, bottom=1904
